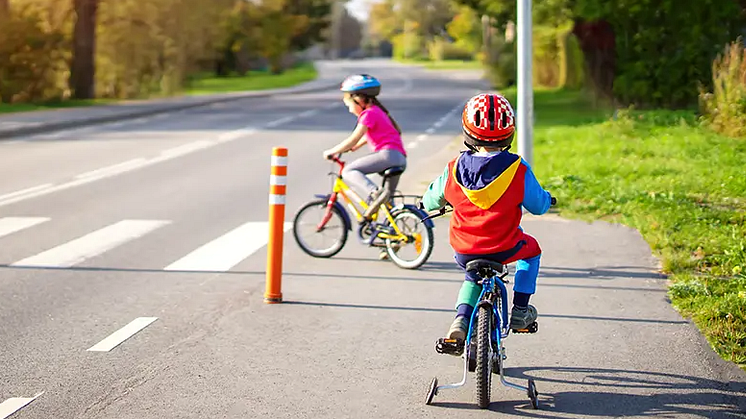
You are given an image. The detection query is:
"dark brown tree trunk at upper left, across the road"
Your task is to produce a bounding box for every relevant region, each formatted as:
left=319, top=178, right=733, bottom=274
left=69, top=0, right=98, bottom=99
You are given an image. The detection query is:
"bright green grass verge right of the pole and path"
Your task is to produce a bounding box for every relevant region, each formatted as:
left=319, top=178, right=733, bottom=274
left=504, top=86, right=746, bottom=370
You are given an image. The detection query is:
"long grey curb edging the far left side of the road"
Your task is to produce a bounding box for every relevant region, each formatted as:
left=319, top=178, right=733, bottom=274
left=0, top=82, right=339, bottom=140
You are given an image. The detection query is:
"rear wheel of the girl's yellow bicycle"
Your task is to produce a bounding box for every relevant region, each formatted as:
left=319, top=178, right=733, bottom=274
left=386, top=208, right=435, bottom=269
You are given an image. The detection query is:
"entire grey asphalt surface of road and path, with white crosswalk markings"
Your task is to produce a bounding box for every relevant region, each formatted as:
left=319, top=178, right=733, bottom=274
left=0, top=61, right=746, bottom=419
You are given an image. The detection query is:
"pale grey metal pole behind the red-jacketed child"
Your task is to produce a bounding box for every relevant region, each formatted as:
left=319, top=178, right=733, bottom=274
left=516, top=0, right=534, bottom=165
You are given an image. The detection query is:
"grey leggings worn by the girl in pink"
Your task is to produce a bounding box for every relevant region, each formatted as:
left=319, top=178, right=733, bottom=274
left=342, top=149, right=407, bottom=199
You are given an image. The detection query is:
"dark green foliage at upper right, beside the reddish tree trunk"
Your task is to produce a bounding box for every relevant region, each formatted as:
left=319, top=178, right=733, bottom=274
left=574, top=0, right=743, bottom=107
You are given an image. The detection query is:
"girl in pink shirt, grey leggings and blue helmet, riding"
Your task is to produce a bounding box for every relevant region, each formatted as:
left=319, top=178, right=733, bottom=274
left=324, top=74, right=407, bottom=219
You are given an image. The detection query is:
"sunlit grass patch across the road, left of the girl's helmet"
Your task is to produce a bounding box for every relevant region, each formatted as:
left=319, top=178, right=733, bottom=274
left=185, top=63, right=317, bottom=95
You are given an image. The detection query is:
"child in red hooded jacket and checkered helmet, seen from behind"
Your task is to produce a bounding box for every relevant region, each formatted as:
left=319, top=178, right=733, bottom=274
left=421, top=94, right=552, bottom=339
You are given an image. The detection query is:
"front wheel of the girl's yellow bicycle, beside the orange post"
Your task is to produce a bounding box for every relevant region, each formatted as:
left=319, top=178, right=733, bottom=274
left=293, top=199, right=347, bottom=258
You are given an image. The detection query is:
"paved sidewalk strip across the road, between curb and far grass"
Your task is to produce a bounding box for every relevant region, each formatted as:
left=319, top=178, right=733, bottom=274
left=0, top=61, right=344, bottom=139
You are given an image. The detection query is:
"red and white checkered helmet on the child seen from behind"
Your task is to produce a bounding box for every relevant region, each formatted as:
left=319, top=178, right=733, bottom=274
left=461, top=93, right=515, bottom=148
